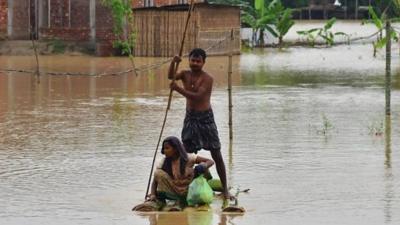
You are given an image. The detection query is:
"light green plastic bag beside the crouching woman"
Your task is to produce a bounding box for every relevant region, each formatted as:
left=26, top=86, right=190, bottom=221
left=186, top=175, right=214, bottom=206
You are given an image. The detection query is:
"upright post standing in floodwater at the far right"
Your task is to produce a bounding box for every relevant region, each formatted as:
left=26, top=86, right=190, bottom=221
left=385, top=20, right=392, bottom=115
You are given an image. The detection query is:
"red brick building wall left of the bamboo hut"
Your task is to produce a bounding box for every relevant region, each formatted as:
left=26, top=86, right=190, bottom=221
left=0, top=0, right=112, bottom=43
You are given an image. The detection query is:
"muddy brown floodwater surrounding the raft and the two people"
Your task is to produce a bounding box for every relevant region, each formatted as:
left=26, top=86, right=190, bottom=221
left=0, top=22, right=400, bottom=225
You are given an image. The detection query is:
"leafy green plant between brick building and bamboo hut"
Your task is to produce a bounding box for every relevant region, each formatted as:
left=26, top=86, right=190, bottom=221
left=102, top=0, right=136, bottom=55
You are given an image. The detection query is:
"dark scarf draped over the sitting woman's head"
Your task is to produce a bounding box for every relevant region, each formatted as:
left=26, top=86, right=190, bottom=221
left=161, top=136, right=189, bottom=177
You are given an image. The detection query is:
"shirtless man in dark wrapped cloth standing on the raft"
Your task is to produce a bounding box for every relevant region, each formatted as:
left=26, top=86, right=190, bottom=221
left=168, top=48, right=231, bottom=199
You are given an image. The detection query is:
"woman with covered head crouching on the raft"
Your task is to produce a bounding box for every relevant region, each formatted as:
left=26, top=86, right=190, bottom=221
left=148, top=137, right=214, bottom=207
